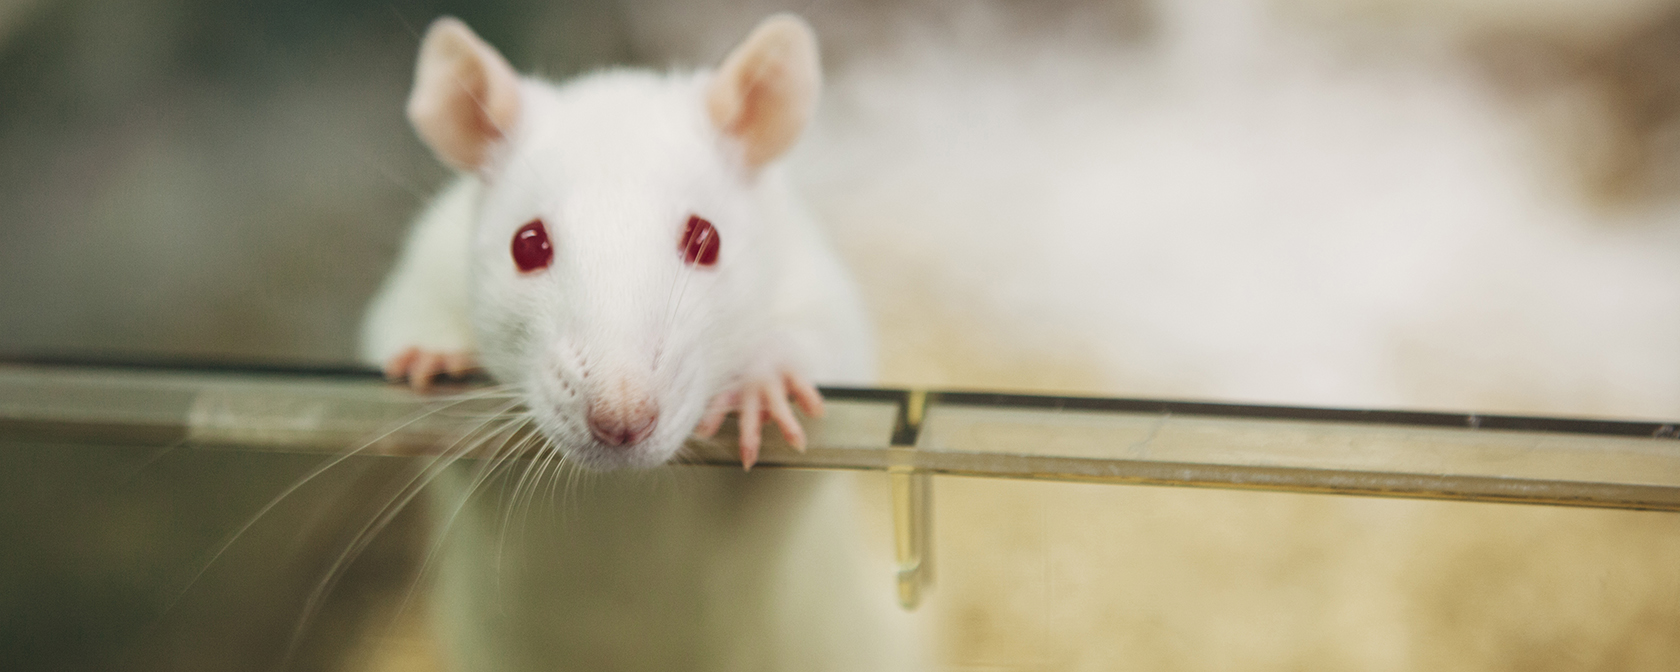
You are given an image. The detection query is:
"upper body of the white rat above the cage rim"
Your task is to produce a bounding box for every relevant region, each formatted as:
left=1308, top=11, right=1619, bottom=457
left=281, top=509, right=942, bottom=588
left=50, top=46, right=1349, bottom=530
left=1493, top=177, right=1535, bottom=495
left=363, top=15, right=874, bottom=469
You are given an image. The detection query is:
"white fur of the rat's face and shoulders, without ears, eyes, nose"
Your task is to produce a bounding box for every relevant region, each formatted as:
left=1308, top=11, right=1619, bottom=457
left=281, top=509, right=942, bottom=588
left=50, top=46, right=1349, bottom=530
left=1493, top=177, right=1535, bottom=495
left=363, top=71, right=874, bottom=467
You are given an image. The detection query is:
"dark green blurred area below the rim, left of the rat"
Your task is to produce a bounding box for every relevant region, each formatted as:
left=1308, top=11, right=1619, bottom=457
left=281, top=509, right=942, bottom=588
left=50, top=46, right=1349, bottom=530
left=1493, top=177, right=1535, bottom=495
left=0, top=442, right=423, bottom=670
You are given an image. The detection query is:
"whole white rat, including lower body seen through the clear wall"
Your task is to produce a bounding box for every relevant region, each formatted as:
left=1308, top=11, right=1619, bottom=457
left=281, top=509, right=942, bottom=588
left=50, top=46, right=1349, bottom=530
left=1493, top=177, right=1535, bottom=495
left=363, top=15, right=921, bottom=670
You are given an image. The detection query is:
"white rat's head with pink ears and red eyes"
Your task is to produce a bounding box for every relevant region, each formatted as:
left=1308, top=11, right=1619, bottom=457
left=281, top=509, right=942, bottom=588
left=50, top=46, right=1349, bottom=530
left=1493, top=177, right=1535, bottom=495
left=408, top=15, right=820, bottom=469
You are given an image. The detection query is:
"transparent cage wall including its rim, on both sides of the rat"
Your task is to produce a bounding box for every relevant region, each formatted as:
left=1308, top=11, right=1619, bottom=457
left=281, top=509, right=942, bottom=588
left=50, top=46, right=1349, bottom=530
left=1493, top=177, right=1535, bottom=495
left=0, top=363, right=1680, bottom=670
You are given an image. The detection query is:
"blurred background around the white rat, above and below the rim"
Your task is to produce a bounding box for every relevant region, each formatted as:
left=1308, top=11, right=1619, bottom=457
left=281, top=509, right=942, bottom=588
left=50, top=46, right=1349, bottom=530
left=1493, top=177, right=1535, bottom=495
left=0, top=0, right=1680, bottom=670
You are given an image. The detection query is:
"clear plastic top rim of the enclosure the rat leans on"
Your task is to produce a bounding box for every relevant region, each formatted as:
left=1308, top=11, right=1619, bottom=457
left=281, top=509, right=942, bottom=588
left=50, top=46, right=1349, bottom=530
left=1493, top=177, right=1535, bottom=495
left=0, top=361, right=1680, bottom=511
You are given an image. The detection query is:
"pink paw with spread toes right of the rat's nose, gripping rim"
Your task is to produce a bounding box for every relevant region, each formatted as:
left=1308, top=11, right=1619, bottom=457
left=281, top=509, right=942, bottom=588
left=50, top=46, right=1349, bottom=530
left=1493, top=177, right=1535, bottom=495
left=694, top=371, right=823, bottom=469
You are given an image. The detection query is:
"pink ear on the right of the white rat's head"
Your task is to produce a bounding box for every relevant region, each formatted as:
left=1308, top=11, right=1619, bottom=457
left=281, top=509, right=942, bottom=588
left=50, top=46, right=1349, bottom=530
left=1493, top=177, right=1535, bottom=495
left=706, top=13, right=823, bottom=168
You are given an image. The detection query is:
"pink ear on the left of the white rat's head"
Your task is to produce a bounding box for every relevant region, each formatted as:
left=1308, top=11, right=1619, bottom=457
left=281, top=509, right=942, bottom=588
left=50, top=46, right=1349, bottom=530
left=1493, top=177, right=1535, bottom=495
left=408, top=17, right=519, bottom=170
